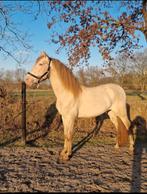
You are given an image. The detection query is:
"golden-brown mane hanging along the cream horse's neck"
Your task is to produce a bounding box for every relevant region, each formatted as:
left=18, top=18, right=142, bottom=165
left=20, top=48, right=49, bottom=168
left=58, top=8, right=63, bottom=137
left=53, top=59, right=82, bottom=97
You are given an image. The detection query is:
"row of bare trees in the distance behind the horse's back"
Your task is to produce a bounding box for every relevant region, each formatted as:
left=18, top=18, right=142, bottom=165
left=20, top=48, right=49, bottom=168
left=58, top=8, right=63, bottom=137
left=77, top=49, right=147, bottom=92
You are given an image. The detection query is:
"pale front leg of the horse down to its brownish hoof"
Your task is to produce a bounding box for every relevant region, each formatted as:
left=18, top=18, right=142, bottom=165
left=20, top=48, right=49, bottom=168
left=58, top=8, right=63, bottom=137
left=59, top=116, right=75, bottom=160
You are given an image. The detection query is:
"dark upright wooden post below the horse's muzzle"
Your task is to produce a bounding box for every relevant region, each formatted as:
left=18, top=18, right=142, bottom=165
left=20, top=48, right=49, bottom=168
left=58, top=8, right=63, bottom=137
left=21, top=81, right=26, bottom=145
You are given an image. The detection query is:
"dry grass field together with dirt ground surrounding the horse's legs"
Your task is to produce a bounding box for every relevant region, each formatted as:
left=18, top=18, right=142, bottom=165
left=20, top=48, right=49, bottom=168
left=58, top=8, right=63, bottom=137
left=0, top=90, right=147, bottom=192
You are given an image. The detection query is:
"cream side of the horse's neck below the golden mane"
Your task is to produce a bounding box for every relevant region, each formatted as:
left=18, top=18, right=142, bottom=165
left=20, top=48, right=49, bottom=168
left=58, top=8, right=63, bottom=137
left=50, top=67, right=65, bottom=98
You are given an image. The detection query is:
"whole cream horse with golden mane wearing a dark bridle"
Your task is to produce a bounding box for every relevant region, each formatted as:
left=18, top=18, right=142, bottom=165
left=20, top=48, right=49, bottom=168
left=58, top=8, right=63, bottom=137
left=25, top=52, right=134, bottom=160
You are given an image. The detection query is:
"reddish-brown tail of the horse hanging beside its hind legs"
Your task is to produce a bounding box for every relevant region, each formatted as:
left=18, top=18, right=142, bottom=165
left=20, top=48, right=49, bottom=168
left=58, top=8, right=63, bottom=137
left=117, top=116, right=129, bottom=146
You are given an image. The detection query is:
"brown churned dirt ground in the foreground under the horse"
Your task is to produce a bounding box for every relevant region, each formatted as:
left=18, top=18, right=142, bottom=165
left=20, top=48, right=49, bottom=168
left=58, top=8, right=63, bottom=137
left=0, top=129, right=147, bottom=192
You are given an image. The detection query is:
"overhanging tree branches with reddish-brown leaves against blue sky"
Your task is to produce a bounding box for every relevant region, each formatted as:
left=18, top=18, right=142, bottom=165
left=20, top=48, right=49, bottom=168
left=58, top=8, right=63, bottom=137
left=48, top=0, right=147, bottom=65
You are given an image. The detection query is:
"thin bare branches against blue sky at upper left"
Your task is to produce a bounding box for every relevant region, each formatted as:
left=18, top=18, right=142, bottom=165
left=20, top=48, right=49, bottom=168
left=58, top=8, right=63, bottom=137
left=0, top=1, right=43, bottom=64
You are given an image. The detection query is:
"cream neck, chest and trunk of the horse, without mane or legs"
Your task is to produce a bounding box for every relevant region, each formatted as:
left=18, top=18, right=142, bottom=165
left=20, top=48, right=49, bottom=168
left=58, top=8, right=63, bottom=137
left=50, top=65, right=125, bottom=118
